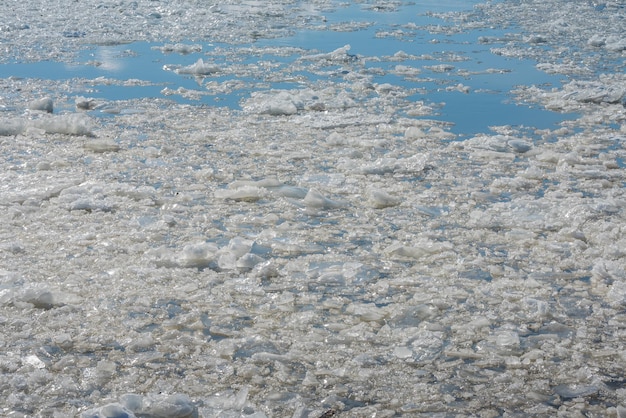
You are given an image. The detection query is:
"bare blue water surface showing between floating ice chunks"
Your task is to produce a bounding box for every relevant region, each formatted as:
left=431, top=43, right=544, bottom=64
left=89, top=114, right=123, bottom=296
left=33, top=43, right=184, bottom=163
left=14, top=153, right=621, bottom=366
left=0, top=1, right=571, bottom=138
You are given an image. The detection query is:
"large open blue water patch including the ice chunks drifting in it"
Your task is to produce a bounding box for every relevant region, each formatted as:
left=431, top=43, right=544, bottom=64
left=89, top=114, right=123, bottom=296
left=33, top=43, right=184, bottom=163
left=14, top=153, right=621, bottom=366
left=0, top=0, right=573, bottom=138
